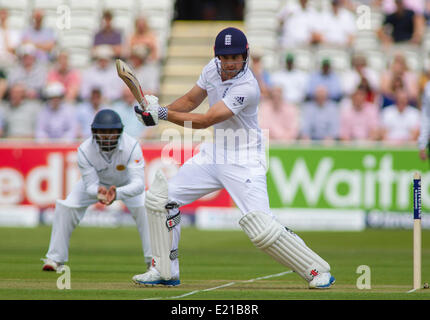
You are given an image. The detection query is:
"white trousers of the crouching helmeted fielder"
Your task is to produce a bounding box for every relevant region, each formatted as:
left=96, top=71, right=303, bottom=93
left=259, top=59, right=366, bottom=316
left=46, top=181, right=152, bottom=263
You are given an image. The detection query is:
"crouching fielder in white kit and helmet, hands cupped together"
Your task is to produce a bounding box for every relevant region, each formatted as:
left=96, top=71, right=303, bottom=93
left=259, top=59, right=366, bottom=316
left=42, top=109, right=152, bottom=271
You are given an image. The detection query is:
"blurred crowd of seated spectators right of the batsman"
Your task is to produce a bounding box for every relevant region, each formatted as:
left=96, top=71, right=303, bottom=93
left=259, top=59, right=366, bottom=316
left=255, top=0, right=430, bottom=144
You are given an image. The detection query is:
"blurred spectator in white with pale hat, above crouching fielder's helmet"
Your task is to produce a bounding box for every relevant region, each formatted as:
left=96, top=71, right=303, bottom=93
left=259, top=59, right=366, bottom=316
left=80, top=46, right=122, bottom=101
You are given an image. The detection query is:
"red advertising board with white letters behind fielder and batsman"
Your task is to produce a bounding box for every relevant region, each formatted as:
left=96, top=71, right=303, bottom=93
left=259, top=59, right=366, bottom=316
left=0, top=142, right=233, bottom=210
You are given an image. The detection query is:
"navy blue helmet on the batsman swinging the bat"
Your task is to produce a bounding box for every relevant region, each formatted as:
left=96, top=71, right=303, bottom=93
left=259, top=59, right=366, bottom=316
left=214, top=27, right=249, bottom=57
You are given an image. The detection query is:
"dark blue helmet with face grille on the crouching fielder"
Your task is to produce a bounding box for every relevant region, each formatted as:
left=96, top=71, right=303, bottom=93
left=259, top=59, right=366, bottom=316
left=91, top=109, right=124, bottom=151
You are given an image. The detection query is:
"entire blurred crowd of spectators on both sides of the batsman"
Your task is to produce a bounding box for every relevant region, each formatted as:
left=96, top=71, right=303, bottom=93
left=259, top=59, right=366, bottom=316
left=0, top=0, right=430, bottom=143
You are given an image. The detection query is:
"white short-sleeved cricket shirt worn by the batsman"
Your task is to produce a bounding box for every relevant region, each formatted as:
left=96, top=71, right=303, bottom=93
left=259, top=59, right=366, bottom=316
left=197, top=58, right=264, bottom=163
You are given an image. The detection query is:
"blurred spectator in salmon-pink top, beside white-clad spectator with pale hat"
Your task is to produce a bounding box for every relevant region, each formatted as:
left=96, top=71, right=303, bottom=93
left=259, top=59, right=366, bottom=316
left=47, top=51, right=81, bottom=103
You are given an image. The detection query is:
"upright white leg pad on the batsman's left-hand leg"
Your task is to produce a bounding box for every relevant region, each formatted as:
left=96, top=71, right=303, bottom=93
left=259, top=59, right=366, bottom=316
left=145, top=170, right=181, bottom=280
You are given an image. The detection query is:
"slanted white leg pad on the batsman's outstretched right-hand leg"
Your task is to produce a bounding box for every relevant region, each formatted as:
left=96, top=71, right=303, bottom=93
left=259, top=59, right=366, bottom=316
left=239, top=211, right=330, bottom=281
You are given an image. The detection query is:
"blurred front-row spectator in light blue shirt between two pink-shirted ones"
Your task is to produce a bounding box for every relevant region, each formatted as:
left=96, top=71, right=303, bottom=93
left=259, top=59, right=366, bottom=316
left=301, top=85, right=339, bottom=141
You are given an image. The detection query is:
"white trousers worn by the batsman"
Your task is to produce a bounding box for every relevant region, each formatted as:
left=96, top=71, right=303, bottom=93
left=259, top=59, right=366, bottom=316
left=165, top=153, right=272, bottom=278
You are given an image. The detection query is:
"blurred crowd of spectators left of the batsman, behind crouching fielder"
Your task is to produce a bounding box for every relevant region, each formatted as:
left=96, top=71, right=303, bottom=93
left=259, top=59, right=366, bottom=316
left=0, top=8, right=161, bottom=141
